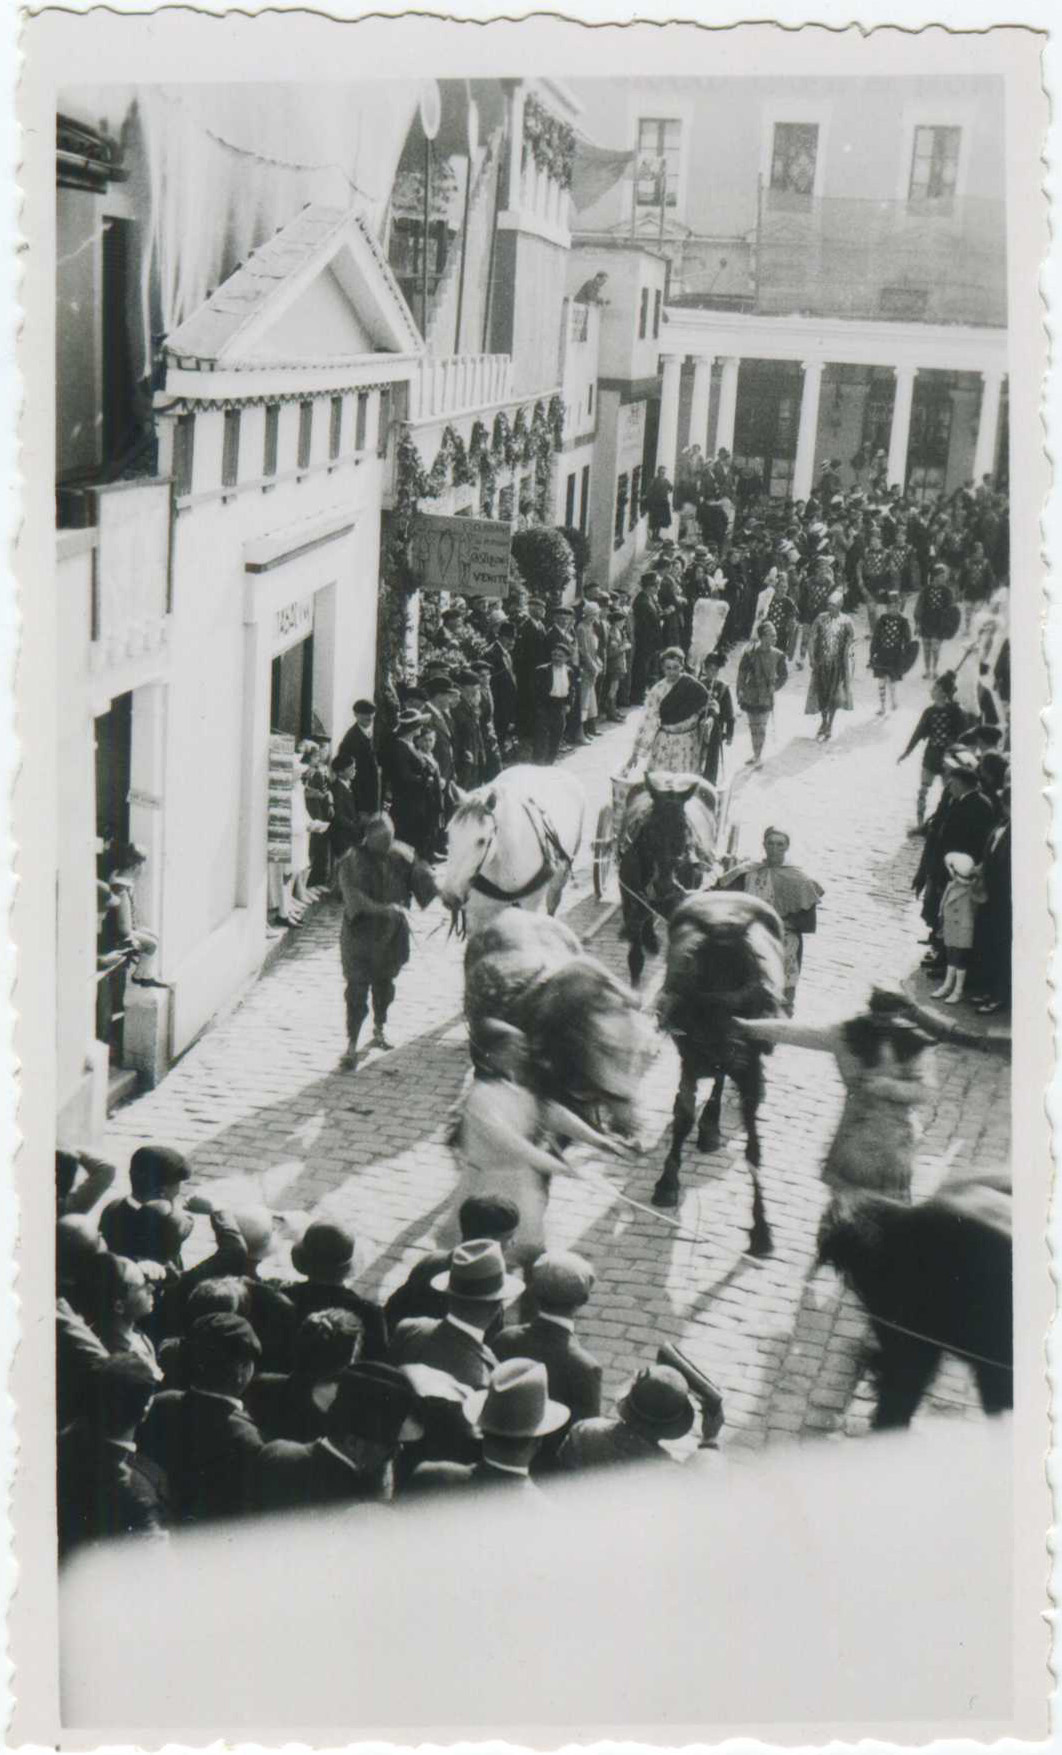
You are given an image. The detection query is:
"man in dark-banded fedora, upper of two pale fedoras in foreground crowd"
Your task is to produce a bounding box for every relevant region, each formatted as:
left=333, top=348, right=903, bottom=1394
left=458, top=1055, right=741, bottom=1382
left=390, top=1237, right=523, bottom=1390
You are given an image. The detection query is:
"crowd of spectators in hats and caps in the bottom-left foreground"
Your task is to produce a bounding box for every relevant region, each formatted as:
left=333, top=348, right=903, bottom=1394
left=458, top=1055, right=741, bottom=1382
left=56, top=1146, right=723, bottom=1557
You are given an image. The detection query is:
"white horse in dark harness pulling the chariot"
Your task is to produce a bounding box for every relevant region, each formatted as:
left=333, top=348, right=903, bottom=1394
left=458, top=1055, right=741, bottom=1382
left=439, top=767, right=586, bottom=934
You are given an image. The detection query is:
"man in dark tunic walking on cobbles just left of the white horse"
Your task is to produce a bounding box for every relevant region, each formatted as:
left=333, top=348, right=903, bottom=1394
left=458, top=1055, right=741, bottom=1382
left=335, top=813, right=437, bottom=1072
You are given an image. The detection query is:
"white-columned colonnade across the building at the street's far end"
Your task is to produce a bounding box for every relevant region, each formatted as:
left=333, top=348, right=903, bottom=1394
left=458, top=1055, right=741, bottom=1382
left=657, top=309, right=1006, bottom=500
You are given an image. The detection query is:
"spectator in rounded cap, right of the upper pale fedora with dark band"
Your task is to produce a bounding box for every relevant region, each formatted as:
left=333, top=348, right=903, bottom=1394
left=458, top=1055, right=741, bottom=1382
left=493, top=1250, right=602, bottom=1450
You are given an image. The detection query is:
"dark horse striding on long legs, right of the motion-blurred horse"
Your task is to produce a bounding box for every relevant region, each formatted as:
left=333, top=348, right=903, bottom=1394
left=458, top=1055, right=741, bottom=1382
left=653, top=890, right=785, bottom=1255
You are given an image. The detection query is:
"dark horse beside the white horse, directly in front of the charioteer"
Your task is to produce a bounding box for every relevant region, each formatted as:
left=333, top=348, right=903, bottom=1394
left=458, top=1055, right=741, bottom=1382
left=620, top=774, right=716, bottom=986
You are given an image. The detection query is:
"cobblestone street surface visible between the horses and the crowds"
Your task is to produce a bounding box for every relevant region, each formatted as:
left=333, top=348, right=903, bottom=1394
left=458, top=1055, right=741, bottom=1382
left=102, top=628, right=1009, bottom=1450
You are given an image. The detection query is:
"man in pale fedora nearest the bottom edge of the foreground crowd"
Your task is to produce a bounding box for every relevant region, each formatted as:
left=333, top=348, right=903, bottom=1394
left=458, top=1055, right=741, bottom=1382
left=409, top=1358, right=570, bottom=1492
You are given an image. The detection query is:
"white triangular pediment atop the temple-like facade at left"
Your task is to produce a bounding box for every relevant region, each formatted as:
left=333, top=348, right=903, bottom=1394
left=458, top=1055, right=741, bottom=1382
left=167, top=205, right=423, bottom=367
